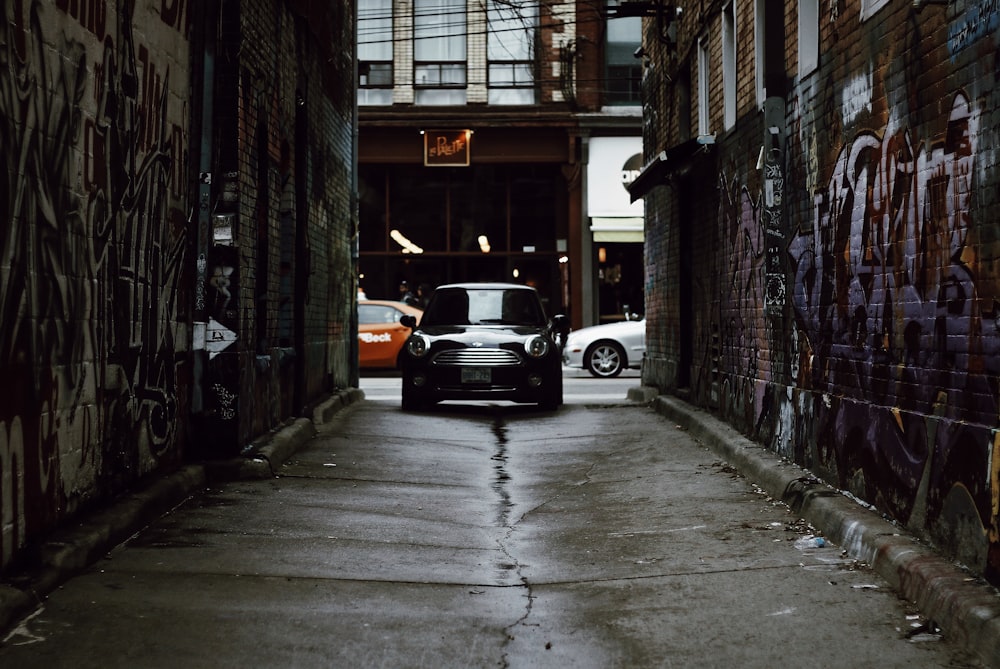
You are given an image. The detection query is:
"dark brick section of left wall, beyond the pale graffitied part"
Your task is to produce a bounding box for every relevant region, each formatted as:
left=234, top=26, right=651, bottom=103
left=203, top=0, right=356, bottom=452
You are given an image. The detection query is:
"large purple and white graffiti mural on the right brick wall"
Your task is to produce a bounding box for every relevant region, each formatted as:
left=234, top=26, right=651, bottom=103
left=789, top=91, right=1000, bottom=570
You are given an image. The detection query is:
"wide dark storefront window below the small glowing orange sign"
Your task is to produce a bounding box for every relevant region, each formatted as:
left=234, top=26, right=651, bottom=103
left=359, top=165, right=565, bottom=308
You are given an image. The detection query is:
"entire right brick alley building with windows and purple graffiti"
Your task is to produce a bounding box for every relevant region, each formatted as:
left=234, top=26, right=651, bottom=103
left=622, top=0, right=1000, bottom=583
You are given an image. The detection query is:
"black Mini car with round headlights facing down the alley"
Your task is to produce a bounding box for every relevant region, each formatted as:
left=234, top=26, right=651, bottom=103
left=399, top=283, right=569, bottom=411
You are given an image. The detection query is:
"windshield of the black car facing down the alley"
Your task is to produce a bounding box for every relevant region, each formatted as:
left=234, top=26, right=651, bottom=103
left=421, top=288, right=545, bottom=327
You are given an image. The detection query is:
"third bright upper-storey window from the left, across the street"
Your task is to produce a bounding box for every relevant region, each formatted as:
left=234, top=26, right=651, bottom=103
left=486, top=0, right=538, bottom=105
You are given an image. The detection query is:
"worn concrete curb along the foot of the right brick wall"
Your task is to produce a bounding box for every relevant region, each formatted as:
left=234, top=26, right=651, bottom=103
left=648, top=390, right=1000, bottom=667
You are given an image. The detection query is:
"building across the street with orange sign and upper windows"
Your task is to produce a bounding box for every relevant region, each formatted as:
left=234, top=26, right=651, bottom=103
left=358, top=0, right=643, bottom=327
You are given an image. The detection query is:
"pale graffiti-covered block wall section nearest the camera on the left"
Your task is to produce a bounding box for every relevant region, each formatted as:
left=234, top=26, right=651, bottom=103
left=0, top=0, right=191, bottom=568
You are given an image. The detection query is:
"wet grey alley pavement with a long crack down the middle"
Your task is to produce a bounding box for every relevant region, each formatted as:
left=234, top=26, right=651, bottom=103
left=0, top=377, right=989, bottom=668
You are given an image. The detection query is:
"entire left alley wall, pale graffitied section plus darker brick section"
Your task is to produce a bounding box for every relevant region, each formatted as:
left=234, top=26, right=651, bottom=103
left=0, top=0, right=356, bottom=570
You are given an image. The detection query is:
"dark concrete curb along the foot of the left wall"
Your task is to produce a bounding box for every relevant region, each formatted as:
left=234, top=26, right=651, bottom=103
left=0, top=388, right=365, bottom=631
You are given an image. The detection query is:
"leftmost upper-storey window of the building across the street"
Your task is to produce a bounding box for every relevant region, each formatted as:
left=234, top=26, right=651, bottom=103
left=358, top=0, right=393, bottom=105
